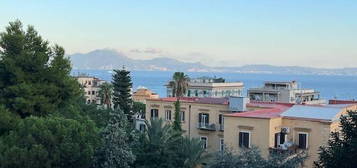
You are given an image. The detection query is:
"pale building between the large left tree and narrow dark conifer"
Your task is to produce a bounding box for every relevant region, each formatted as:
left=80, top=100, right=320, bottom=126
left=75, top=75, right=106, bottom=104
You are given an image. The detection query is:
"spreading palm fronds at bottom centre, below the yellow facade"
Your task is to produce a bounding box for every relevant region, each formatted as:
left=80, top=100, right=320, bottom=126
left=135, top=119, right=205, bottom=168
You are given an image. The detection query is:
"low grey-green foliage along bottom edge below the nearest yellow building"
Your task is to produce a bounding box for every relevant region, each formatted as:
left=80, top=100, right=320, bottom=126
left=209, top=147, right=307, bottom=168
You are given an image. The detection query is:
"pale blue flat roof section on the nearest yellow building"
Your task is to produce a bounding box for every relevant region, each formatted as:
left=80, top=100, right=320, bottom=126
left=281, top=104, right=350, bottom=121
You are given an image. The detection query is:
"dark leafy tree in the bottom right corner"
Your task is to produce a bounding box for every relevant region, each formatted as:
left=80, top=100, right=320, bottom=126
left=315, top=111, right=357, bottom=168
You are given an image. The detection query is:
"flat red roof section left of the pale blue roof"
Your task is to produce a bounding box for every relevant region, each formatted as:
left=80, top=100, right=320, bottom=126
left=225, top=103, right=293, bottom=118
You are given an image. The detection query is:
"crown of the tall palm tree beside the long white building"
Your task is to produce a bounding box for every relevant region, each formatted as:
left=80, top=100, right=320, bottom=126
left=169, top=72, right=190, bottom=98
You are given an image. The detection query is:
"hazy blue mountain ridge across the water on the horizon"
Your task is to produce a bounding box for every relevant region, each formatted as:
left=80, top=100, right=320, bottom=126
left=69, top=49, right=357, bottom=75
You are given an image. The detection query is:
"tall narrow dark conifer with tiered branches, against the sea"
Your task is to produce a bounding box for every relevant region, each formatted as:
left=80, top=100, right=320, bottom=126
left=112, top=69, right=134, bottom=121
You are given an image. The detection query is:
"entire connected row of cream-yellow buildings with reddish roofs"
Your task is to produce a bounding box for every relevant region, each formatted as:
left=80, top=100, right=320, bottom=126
left=145, top=97, right=357, bottom=167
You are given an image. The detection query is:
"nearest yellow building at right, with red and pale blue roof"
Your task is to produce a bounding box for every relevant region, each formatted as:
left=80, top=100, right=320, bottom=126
left=224, top=104, right=357, bottom=167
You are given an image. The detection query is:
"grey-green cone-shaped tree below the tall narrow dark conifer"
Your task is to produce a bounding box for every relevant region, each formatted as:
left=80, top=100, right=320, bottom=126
left=94, top=110, right=135, bottom=168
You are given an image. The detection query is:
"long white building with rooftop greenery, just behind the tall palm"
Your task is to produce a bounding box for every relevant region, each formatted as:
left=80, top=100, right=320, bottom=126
left=166, top=77, right=244, bottom=97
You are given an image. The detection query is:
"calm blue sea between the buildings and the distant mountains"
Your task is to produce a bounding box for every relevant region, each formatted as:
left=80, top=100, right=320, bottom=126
left=72, top=70, right=357, bottom=99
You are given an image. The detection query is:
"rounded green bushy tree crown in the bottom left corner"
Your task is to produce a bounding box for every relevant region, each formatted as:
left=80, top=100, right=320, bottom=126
left=0, top=117, right=99, bottom=168
